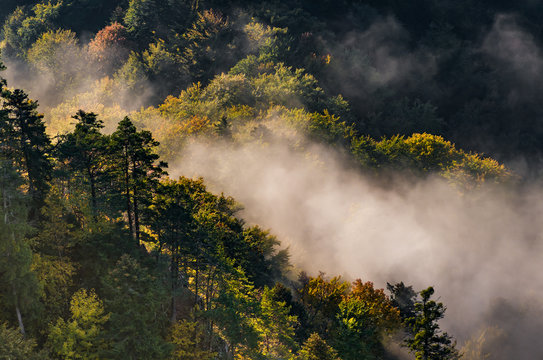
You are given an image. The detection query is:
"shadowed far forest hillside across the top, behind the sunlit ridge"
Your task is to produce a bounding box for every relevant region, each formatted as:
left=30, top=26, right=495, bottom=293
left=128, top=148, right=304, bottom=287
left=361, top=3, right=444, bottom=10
left=0, top=0, right=543, bottom=171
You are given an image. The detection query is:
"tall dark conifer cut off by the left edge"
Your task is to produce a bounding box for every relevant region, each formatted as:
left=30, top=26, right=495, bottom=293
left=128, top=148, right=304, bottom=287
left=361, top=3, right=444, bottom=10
left=0, top=89, right=43, bottom=335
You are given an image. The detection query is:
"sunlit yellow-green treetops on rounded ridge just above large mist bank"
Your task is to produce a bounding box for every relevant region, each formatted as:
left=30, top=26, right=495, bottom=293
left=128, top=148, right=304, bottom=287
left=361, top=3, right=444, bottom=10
left=134, top=56, right=354, bottom=155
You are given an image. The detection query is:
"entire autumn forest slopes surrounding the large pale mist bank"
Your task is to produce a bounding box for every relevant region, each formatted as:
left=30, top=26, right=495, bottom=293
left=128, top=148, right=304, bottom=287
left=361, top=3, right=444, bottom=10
left=0, top=0, right=543, bottom=360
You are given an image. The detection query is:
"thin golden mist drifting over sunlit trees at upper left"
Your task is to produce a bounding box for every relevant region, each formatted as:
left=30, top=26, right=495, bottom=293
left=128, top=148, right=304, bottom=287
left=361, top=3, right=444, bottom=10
left=2, top=26, right=159, bottom=136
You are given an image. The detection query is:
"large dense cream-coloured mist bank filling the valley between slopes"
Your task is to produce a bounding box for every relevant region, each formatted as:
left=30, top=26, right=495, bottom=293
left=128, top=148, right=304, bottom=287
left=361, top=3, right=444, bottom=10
left=170, top=133, right=543, bottom=355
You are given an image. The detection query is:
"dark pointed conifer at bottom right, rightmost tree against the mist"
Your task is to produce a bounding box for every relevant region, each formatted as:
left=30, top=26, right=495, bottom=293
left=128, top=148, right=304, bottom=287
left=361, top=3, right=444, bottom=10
left=405, top=286, right=460, bottom=360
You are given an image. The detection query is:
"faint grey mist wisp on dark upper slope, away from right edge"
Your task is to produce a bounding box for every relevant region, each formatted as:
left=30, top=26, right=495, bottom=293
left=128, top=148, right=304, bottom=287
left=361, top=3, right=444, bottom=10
left=323, top=14, right=437, bottom=106
